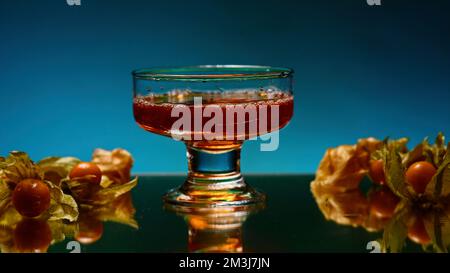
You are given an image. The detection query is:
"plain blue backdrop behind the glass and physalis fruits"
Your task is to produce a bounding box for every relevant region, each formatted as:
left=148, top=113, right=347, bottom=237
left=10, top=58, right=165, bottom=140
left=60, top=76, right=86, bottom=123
left=0, top=0, right=450, bottom=172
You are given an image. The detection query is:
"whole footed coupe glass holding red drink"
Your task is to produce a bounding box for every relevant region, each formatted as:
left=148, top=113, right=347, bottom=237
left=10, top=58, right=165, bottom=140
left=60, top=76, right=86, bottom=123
left=133, top=65, right=293, bottom=207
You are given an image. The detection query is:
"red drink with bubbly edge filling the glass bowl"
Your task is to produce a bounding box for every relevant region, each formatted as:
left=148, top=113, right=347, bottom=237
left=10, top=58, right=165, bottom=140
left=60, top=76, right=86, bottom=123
left=133, top=90, right=293, bottom=143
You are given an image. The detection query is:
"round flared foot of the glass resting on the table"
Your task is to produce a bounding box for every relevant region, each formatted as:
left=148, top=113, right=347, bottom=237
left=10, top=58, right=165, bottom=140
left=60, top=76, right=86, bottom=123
left=163, top=177, right=266, bottom=208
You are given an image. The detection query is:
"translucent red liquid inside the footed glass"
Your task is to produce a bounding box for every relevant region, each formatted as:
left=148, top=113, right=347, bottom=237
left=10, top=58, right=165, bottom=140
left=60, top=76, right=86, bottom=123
left=133, top=91, right=294, bottom=145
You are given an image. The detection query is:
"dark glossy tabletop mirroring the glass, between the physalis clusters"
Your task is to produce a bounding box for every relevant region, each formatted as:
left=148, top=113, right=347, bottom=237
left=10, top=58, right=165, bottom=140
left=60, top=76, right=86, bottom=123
left=26, top=175, right=428, bottom=252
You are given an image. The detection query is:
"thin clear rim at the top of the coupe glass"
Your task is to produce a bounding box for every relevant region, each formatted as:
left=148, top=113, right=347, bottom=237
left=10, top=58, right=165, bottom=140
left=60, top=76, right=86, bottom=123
left=132, top=65, right=294, bottom=81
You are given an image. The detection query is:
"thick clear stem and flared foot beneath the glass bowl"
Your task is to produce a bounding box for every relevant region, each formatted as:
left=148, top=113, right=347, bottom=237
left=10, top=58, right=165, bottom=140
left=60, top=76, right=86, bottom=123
left=165, top=142, right=265, bottom=207
